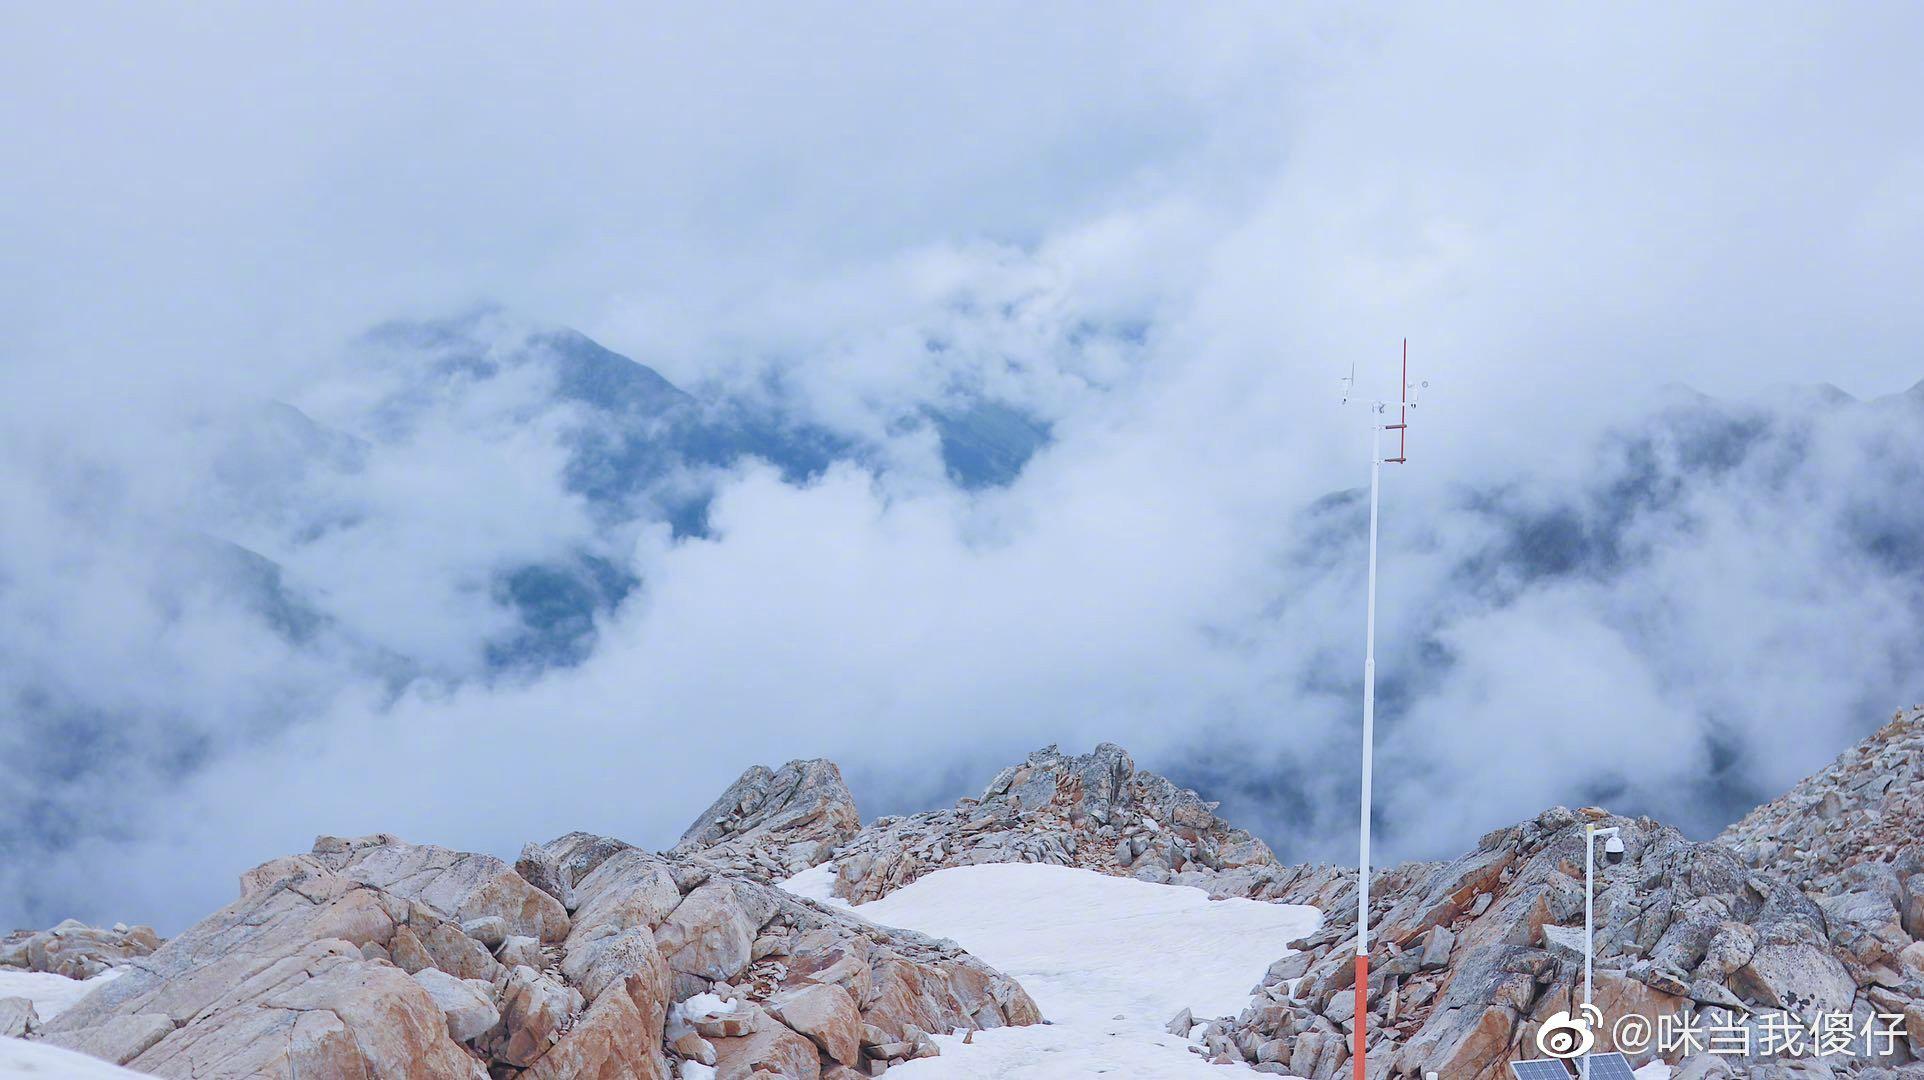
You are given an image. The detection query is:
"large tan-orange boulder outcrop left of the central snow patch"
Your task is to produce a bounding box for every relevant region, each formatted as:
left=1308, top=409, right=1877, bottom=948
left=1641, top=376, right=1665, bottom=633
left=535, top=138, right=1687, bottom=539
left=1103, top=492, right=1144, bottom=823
left=15, top=834, right=1039, bottom=1080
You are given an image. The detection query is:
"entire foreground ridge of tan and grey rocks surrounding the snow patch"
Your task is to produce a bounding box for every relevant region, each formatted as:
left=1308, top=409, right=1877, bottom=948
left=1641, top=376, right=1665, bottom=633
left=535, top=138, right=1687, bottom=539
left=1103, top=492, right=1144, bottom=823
left=26, top=710, right=1924, bottom=1080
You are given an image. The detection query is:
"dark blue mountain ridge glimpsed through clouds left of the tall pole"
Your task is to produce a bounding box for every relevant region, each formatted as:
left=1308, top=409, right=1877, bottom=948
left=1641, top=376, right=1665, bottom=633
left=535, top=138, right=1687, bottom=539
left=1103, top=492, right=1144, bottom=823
left=204, top=310, right=1051, bottom=670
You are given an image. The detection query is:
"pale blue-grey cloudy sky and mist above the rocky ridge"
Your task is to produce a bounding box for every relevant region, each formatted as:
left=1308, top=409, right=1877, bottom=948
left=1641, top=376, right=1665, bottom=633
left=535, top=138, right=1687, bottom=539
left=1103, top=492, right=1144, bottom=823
left=0, top=4, right=1924, bottom=926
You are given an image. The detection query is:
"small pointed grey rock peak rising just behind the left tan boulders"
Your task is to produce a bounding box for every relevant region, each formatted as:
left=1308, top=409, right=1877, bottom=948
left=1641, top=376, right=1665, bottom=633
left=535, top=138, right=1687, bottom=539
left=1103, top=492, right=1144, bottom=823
left=673, top=759, right=862, bottom=880
